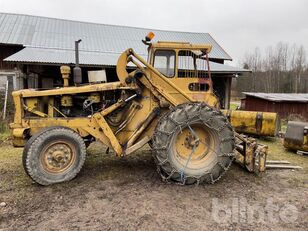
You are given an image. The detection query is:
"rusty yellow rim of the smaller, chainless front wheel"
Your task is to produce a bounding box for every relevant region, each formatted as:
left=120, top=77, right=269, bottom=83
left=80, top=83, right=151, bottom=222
left=40, top=141, right=77, bottom=174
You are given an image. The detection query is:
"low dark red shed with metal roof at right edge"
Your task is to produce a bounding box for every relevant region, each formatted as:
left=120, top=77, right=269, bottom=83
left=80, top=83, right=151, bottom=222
left=241, top=92, right=308, bottom=119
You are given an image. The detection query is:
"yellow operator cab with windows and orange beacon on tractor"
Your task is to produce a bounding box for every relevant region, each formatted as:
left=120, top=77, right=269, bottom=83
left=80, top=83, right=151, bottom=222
left=143, top=32, right=213, bottom=93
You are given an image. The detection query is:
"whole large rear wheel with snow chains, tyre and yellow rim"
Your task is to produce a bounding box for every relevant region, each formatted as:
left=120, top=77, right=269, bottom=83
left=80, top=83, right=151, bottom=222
left=152, top=103, right=235, bottom=184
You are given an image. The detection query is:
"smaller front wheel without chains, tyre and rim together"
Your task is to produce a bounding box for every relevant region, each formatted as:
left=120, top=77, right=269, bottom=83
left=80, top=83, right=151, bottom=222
left=22, top=127, right=86, bottom=185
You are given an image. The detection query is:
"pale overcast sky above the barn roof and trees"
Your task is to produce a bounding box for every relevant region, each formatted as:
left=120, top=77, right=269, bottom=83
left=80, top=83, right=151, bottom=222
left=0, top=0, right=308, bottom=66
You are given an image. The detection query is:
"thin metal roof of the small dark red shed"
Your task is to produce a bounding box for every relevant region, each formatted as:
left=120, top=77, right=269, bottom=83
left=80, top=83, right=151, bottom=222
left=243, top=92, right=308, bottom=103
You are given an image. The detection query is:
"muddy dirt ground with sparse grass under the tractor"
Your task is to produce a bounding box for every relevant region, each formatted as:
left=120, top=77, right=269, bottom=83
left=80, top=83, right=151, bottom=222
left=0, top=140, right=308, bottom=230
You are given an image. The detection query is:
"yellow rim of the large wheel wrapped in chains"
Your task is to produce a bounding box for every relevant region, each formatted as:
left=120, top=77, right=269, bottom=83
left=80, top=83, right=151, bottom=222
left=171, top=124, right=217, bottom=169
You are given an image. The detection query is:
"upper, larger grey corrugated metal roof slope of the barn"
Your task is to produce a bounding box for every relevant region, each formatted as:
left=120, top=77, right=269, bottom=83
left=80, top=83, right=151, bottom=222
left=0, top=13, right=232, bottom=60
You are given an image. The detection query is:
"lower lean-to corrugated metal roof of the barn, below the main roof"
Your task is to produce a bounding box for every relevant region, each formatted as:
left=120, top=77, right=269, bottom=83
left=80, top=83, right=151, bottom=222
left=5, top=47, right=248, bottom=73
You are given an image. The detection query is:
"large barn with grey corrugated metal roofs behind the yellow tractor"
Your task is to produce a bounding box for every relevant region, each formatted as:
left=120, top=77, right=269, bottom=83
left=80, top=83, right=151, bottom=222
left=0, top=13, right=248, bottom=107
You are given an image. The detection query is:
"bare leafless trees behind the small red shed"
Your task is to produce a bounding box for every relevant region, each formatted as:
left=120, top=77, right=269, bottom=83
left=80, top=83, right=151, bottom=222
left=237, top=42, right=308, bottom=93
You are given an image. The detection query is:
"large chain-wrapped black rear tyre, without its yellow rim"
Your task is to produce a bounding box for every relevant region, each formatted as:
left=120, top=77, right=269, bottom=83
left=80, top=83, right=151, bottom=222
left=152, top=103, right=235, bottom=184
